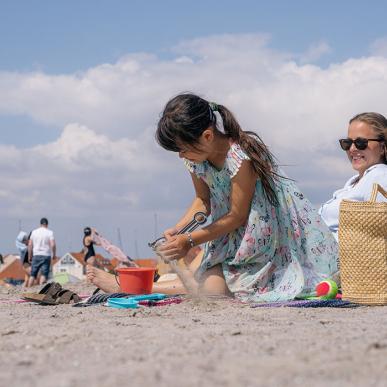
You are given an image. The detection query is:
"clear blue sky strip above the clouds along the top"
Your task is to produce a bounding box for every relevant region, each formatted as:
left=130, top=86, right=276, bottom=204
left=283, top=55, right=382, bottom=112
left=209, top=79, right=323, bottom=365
left=0, top=0, right=386, bottom=73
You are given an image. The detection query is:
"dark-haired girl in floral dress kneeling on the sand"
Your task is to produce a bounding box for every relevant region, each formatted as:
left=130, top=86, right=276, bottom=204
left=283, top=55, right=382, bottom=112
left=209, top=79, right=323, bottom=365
left=155, top=94, right=338, bottom=302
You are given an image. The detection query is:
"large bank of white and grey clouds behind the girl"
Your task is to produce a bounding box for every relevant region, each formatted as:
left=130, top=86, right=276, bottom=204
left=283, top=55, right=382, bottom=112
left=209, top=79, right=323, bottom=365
left=0, top=35, right=387, bottom=256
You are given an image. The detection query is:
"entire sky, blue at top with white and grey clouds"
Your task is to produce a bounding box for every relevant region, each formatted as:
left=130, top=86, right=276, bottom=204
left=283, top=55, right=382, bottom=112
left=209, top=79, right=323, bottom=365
left=0, top=0, right=387, bottom=257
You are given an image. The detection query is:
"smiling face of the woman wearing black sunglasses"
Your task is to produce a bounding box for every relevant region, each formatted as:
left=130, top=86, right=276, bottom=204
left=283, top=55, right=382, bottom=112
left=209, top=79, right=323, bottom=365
left=347, top=121, right=384, bottom=176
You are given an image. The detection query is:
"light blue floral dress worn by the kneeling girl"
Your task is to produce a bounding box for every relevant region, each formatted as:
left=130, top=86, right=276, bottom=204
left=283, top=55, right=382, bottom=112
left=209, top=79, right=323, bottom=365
left=185, top=144, right=338, bottom=302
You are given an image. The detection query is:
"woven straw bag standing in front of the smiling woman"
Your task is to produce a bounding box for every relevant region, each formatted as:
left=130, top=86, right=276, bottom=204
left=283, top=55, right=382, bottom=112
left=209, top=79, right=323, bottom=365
left=339, top=184, right=387, bottom=305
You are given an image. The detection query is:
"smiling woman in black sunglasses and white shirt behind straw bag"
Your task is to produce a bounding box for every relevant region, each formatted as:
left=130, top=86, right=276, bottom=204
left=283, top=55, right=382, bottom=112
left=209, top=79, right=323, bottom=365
left=319, top=113, right=387, bottom=239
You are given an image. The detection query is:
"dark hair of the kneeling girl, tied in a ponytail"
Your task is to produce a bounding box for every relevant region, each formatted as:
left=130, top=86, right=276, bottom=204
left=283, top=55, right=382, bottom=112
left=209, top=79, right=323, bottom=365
left=156, top=93, right=279, bottom=205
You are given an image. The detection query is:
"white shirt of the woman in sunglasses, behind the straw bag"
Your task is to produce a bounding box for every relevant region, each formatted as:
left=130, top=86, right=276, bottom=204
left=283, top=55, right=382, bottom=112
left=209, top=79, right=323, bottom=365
left=319, top=164, right=387, bottom=239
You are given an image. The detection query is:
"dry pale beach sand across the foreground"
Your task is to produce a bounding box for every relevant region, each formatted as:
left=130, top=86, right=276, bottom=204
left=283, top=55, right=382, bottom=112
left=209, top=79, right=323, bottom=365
left=0, top=285, right=387, bottom=387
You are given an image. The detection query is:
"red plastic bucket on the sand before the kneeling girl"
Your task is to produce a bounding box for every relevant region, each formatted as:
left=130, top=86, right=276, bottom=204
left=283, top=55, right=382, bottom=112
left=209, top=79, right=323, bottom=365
left=117, top=267, right=156, bottom=294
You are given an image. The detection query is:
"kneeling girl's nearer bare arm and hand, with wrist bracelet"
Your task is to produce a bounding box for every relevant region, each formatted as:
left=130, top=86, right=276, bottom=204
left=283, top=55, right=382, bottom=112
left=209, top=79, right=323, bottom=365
left=160, top=160, right=257, bottom=259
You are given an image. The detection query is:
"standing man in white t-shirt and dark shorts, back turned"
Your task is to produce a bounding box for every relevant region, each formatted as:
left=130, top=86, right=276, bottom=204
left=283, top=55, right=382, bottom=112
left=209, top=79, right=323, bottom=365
left=28, top=218, right=56, bottom=286
